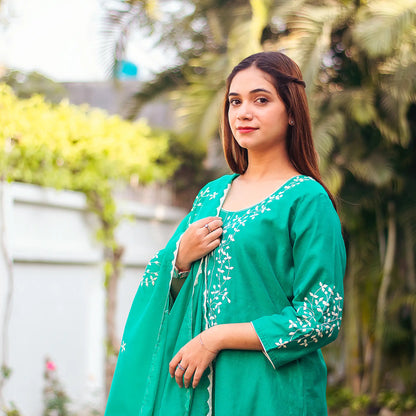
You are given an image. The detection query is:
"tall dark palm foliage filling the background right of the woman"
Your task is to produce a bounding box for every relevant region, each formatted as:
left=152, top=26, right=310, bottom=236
left=274, top=0, right=416, bottom=398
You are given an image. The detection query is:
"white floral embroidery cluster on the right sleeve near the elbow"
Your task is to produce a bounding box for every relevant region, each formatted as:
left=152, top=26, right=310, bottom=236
left=275, top=282, right=342, bottom=348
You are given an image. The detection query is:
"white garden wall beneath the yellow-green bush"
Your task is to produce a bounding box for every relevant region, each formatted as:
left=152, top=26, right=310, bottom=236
left=0, top=183, right=184, bottom=416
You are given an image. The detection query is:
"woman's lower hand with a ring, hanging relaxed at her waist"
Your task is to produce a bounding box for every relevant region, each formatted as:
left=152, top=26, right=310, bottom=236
left=169, top=328, right=219, bottom=388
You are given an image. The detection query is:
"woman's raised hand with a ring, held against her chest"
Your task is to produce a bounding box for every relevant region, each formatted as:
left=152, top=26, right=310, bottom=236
left=176, top=217, right=222, bottom=270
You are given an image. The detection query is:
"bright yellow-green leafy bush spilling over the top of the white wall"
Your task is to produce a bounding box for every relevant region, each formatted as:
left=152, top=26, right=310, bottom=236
left=0, top=85, right=175, bottom=192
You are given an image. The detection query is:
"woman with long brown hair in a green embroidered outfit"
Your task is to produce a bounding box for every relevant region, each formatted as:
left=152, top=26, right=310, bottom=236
left=106, top=52, right=345, bottom=416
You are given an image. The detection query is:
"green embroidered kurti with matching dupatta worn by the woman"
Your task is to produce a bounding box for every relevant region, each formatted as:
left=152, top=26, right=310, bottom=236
left=106, top=175, right=345, bottom=416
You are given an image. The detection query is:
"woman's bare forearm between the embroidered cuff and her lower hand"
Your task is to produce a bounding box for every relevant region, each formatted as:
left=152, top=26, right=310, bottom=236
left=201, top=322, right=263, bottom=351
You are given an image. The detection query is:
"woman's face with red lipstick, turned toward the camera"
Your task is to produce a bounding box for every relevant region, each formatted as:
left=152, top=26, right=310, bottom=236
left=228, top=66, right=289, bottom=152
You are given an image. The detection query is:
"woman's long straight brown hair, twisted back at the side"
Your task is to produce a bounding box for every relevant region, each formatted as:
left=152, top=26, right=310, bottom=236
left=221, top=52, right=335, bottom=206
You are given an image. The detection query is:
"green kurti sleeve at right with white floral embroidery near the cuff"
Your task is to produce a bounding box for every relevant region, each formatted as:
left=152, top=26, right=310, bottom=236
left=252, top=193, right=346, bottom=368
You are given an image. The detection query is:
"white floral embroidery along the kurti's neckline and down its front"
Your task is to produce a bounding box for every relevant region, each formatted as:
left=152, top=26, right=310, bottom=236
left=207, top=176, right=312, bottom=326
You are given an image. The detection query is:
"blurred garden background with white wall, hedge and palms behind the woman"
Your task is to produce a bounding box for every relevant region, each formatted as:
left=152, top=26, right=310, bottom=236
left=0, top=0, right=416, bottom=416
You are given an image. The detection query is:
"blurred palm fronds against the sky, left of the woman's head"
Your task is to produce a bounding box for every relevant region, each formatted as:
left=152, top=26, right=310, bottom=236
left=106, top=0, right=258, bottom=144
